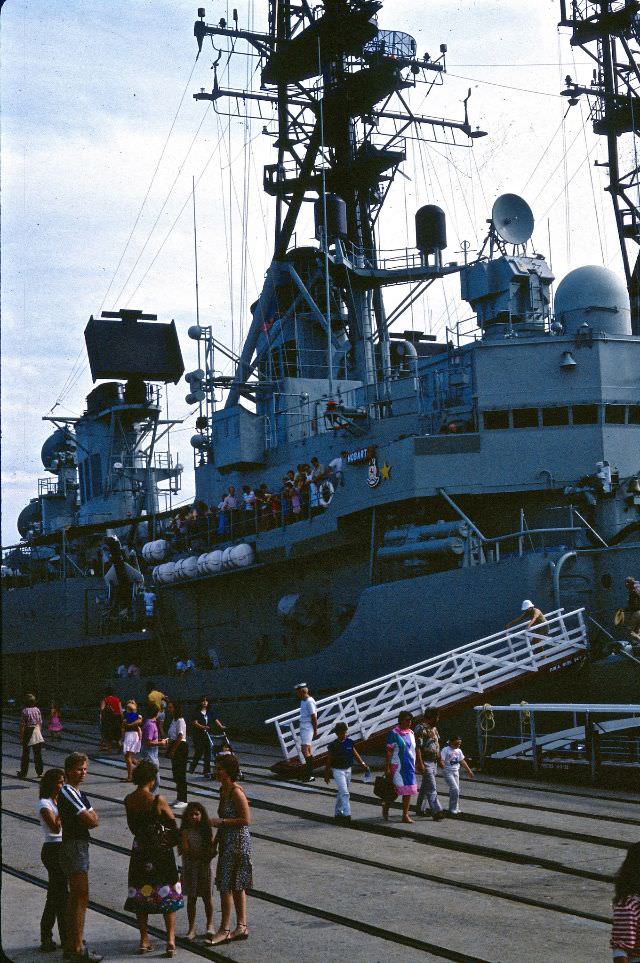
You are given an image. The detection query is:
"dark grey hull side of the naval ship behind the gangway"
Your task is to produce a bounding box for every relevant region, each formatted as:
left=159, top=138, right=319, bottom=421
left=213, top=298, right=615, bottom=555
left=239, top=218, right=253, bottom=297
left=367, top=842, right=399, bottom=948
left=3, top=545, right=640, bottom=735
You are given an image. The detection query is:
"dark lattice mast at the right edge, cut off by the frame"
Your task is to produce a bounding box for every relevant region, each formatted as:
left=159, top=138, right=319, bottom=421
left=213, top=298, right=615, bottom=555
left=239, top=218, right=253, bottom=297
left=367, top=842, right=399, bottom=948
left=560, top=0, right=640, bottom=335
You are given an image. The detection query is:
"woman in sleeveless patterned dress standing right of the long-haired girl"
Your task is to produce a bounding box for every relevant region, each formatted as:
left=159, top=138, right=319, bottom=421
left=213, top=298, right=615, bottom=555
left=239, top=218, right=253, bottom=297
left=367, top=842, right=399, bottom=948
left=208, top=753, right=253, bottom=944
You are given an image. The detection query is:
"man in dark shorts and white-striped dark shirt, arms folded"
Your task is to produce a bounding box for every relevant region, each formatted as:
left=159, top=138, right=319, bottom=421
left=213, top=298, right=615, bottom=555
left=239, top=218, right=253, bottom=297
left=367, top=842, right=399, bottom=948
left=58, top=752, right=102, bottom=963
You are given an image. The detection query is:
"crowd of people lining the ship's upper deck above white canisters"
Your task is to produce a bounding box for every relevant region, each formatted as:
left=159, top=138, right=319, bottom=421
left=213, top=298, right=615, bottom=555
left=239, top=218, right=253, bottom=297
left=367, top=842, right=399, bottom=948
left=165, top=451, right=347, bottom=551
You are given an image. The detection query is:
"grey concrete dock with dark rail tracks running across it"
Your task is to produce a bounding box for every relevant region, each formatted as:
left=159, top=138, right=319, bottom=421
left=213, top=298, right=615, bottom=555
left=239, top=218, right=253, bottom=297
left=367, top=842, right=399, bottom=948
left=2, top=719, right=640, bottom=963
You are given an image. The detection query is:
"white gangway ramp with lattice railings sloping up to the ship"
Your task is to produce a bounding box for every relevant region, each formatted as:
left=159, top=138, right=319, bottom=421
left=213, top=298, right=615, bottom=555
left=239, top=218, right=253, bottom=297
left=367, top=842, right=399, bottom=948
left=266, top=608, right=588, bottom=759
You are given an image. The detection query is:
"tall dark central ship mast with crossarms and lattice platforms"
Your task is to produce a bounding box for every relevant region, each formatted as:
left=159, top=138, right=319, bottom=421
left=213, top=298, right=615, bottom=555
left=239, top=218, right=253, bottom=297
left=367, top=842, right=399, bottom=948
left=194, top=0, right=482, bottom=407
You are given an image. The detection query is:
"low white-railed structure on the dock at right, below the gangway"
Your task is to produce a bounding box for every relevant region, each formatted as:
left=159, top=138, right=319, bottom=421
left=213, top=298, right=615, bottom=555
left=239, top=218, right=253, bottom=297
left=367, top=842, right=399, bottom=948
left=474, top=702, right=640, bottom=778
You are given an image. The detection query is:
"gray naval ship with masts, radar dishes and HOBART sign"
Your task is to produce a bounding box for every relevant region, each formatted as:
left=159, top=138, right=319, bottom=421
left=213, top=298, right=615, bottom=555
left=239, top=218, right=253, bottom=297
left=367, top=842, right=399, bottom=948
left=3, top=0, right=640, bottom=727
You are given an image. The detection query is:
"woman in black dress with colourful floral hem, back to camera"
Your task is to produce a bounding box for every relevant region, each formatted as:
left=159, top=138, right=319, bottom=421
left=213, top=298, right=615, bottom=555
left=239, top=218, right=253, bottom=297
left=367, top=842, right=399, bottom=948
left=124, top=760, right=184, bottom=958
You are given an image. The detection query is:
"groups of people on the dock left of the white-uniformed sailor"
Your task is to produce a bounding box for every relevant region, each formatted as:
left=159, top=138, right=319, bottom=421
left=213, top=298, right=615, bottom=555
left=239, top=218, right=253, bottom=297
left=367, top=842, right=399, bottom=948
left=30, top=687, right=253, bottom=963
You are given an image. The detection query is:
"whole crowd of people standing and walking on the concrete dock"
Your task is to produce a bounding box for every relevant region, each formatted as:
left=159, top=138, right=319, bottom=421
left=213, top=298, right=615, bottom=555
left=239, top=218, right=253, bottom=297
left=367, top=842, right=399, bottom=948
left=18, top=682, right=640, bottom=963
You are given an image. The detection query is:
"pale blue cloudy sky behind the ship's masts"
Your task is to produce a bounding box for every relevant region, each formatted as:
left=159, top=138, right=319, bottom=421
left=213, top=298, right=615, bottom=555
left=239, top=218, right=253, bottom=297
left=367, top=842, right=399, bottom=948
left=0, top=0, right=620, bottom=545
